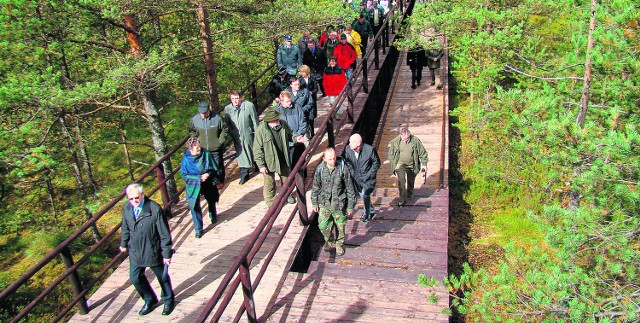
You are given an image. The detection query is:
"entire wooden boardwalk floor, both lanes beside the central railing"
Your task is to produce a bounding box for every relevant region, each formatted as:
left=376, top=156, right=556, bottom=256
left=71, top=41, right=448, bottom=322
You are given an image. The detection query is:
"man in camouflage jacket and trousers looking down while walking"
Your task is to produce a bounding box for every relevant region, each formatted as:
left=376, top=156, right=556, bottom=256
left=311, top=147, right=356, bottom=256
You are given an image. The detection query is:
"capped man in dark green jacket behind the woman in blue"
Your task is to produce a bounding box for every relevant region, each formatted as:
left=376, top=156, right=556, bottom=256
left=189, top=102, right=229, bottom=188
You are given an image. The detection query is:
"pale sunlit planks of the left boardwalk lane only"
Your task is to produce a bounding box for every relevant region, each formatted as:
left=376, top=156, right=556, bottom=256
left=70, top=52, right=393, bottom=322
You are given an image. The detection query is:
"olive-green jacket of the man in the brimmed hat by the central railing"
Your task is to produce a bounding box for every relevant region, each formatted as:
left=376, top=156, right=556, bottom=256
left=253, top=121, right=297, bottom=175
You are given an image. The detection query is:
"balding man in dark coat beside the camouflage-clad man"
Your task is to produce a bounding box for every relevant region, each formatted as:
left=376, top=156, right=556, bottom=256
left=342, top=133, right=380, bottom=222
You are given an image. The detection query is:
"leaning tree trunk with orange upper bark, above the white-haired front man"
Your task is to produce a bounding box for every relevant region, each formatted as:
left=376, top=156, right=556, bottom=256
left=123, top=14, right=178, bottom=205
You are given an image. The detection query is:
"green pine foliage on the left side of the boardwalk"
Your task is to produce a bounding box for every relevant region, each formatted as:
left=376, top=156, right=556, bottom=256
left=0, top=0, right=354, bottom=321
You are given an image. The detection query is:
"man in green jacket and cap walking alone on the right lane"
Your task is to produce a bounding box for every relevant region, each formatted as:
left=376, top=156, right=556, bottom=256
left=389, top=128, right=429, bottom=207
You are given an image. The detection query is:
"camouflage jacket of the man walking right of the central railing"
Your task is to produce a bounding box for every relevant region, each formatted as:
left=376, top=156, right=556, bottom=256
left=311, top=157, right=356, bottom=213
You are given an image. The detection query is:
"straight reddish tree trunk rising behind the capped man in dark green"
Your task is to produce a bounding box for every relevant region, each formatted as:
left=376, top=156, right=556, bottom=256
left=196, top=6, right=220, bottom=112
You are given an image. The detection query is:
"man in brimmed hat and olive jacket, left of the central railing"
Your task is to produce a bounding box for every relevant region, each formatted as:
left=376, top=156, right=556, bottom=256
left=253, top=107, right=307, bottom=206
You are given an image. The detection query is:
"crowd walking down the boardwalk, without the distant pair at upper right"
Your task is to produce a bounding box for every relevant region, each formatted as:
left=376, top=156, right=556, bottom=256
left=120, top=1, right=436, bottom=315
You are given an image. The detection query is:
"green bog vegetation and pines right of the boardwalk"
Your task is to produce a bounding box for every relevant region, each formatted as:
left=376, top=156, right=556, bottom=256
left=410, top=0, right=640, bottom=322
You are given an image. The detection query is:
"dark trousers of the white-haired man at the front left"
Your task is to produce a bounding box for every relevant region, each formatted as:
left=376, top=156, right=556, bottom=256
left=129, top=264, right=175, bottom=304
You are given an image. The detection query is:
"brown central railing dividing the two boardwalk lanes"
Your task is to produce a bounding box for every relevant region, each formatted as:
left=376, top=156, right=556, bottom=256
left=196, top=1, right=411, bottom=322
